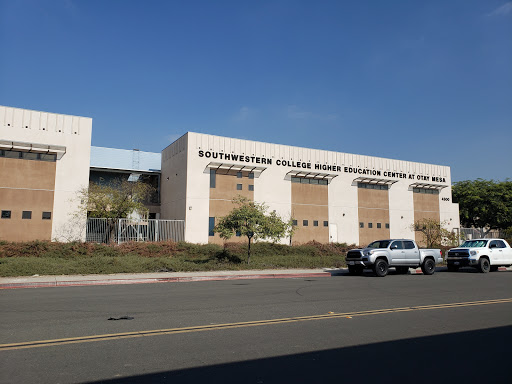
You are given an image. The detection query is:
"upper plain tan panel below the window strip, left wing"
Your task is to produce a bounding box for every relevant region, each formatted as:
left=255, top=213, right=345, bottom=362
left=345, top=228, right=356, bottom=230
left=0, top=157, right=57, bottom=190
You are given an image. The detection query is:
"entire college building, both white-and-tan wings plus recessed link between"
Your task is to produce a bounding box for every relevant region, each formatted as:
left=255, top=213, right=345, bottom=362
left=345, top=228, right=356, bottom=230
left=0, top=106, right=460, bottom=244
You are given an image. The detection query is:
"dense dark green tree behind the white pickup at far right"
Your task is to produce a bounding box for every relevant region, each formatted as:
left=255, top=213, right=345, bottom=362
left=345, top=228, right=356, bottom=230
left=452, top=179, right=512, bottom=234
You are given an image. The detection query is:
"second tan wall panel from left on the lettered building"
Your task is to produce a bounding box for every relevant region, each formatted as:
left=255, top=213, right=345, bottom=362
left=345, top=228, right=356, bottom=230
left=291, top=183, right=329, bottom=244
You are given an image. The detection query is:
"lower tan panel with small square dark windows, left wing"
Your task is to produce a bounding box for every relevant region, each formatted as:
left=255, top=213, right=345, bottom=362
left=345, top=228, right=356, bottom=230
left=0, top=188, right=54, bottom=241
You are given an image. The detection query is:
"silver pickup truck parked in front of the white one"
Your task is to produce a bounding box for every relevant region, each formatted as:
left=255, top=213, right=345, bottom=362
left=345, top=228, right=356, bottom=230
left=346, top=239, right=443, bottom=277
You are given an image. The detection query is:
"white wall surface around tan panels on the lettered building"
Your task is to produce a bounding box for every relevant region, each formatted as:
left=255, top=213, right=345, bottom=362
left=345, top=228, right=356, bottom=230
left=162, top=132, right=459, bottom=244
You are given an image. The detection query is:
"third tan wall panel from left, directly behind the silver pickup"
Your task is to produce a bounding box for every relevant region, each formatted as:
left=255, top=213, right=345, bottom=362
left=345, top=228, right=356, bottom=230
left=357, top=188, right=390, bottom=246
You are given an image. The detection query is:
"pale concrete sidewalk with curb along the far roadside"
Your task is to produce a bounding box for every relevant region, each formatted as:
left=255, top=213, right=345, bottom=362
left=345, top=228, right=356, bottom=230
left=0, top=267, right=512, bottom=289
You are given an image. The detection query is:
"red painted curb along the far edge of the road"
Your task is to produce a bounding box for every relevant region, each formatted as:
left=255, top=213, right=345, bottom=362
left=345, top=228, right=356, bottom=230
left=0, top=272, right=331, bottom=289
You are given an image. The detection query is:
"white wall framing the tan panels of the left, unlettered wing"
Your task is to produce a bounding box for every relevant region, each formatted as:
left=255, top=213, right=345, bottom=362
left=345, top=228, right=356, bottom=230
left=0, top=106, right=92, bottom=241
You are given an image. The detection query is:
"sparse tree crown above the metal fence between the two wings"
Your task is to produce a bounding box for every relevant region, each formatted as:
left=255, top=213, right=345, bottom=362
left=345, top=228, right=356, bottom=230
left=79, top=179, right=154, bottom=219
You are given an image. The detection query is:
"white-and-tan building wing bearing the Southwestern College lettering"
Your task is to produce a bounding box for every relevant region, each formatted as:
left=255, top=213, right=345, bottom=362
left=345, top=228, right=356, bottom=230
left=161, top=132, right=460, bottom=244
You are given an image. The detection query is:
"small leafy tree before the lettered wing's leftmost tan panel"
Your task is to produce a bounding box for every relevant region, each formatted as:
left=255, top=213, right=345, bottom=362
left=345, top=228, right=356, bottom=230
left=213, top=196, right=294, bottom=264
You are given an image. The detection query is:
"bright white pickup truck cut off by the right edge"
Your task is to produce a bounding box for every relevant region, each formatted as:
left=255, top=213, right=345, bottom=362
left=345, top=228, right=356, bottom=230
left=446, top=239, right=512, bottom=273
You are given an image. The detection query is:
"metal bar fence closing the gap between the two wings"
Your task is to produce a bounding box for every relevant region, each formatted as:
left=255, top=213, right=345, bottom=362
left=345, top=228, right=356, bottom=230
left=86, top=218, right=185, bottom=244
